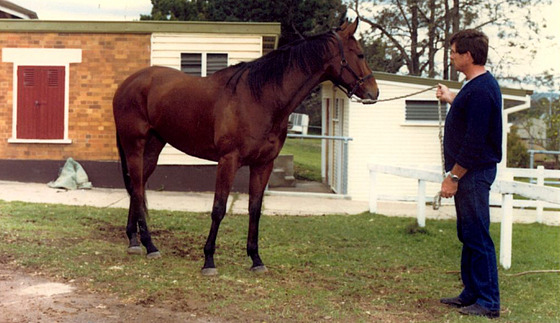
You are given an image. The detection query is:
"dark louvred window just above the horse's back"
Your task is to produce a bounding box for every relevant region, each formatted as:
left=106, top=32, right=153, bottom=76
left=181, top=53, right=228, bottom=76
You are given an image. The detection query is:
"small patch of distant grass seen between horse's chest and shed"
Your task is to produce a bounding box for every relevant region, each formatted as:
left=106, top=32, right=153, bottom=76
left=280, top=138, right=321, bottom=182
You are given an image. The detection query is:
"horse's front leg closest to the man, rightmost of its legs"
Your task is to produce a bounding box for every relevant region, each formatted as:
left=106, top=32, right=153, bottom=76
left=247, top=161, right=274, bottom=272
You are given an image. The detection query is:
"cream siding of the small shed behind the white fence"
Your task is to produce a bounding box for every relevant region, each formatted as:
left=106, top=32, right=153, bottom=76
left=323, top=80, right=441, bottom=201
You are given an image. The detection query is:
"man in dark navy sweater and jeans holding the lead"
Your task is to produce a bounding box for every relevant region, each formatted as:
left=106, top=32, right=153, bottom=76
left=436, top=29, right=502, bottom=318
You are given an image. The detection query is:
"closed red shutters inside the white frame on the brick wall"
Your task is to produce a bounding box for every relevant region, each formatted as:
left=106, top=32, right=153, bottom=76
left=17, top=66, right=64, bottom=139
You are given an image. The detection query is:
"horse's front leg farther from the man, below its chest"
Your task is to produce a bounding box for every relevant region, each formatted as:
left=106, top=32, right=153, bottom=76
left=202, top=155, right=239, bottom=276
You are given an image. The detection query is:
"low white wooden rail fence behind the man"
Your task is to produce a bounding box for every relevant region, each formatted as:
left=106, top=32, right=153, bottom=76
left=368, top=164, right=560, bottom=269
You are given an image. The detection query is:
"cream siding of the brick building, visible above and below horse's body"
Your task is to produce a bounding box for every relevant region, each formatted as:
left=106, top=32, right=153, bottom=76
left=151, top=33, right=262, bottom=165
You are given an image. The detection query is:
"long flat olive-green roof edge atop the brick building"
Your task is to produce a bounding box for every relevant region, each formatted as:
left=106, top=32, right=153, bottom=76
left=0, top=18, right=280, bottom=38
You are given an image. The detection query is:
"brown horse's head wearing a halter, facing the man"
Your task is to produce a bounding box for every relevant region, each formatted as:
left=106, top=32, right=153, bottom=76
left=329, top=19, right=379, bottom=100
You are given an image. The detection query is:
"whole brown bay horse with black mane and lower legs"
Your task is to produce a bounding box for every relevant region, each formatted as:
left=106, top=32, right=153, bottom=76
left=113, top=19, right=379, bottom=275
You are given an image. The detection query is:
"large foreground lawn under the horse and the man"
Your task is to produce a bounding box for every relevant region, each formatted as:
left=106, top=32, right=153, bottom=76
left=0, top=201, right=560, bottom=322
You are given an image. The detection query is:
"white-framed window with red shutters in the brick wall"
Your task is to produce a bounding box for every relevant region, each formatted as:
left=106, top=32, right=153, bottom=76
left=2, top=48, right=82, bottom=144
